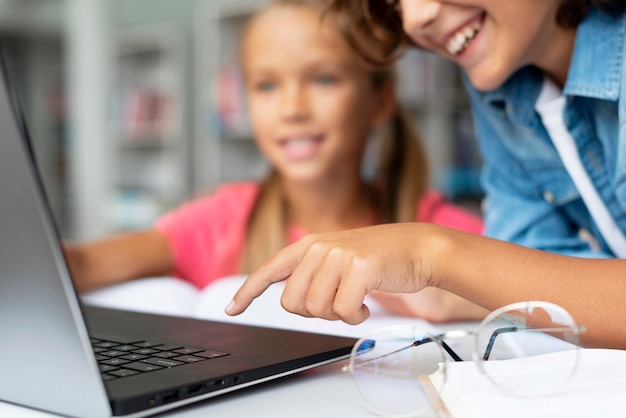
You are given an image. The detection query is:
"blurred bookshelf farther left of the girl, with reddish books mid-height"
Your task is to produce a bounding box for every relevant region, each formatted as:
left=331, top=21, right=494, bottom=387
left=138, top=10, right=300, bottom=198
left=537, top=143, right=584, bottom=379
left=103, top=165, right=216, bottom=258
left=108, top=23, right=188, bottom=231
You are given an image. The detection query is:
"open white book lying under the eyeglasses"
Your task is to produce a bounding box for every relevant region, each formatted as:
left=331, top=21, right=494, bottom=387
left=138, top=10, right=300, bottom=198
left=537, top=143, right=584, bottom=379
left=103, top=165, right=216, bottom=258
left=430, top=349, right=626, bottom=418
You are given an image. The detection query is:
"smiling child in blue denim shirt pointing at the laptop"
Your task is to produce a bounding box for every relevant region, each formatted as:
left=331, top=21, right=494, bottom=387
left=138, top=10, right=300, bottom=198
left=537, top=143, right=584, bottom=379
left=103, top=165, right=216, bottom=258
left=227, top=0, right=626, bottom=348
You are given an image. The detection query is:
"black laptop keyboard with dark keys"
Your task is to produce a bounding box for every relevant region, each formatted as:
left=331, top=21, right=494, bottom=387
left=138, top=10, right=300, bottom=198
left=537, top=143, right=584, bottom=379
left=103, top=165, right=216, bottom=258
left=91, top=338, right=230, bottom=380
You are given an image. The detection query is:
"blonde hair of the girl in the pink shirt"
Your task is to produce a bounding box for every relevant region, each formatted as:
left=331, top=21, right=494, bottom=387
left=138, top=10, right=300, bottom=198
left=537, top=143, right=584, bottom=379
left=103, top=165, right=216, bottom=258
left=240, top=0, right=428, bottom=273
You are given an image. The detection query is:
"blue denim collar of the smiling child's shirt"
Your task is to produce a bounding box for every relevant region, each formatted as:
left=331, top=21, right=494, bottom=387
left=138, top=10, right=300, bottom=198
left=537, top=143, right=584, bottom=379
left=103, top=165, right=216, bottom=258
left=465, top=8, right=626, bottom=119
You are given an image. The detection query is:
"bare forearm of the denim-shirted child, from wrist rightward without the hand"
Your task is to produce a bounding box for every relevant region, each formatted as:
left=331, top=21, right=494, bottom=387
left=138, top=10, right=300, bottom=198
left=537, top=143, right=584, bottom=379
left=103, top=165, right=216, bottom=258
left=431, top=225, right=626, bottom=348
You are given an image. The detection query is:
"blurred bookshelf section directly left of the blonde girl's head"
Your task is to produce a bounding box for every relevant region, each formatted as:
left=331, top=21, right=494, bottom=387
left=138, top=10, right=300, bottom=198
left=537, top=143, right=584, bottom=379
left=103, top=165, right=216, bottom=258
left=194, top=0, right=268, bottom=193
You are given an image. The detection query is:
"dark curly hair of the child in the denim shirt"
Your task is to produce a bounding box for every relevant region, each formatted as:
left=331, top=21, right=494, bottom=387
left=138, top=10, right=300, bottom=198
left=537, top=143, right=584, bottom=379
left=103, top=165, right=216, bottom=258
left=327, top=0, right=626, bottom=66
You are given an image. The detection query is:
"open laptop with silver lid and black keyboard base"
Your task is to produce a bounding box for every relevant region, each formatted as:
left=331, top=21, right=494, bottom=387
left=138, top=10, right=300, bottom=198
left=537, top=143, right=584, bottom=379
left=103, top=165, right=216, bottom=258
left=0, top=49, right=355, bottom=418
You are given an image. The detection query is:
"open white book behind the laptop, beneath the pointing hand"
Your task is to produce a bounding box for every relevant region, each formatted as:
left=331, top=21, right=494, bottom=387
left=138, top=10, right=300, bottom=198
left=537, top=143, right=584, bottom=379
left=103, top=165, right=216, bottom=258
left=82, top=276, right=438, bottom=338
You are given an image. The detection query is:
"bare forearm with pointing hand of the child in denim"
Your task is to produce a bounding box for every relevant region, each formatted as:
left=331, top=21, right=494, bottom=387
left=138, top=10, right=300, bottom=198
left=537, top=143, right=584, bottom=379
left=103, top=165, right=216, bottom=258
left=227, top=223, right=626, bottom=349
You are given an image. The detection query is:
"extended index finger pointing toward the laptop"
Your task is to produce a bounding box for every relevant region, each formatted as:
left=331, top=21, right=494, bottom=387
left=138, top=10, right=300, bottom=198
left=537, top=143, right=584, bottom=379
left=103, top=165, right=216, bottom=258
left=225, top=240, right=303, bottom=316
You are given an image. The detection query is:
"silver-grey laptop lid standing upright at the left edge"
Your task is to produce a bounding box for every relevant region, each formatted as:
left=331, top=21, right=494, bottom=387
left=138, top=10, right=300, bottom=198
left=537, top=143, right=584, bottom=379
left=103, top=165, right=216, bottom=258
left=0, top=49, right=111, bottom=417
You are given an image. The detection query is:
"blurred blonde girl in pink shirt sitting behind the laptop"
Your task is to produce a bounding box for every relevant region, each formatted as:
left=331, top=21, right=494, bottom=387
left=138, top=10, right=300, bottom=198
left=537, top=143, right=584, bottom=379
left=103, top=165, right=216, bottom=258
left=67, top=0, right=485, bottom=321
